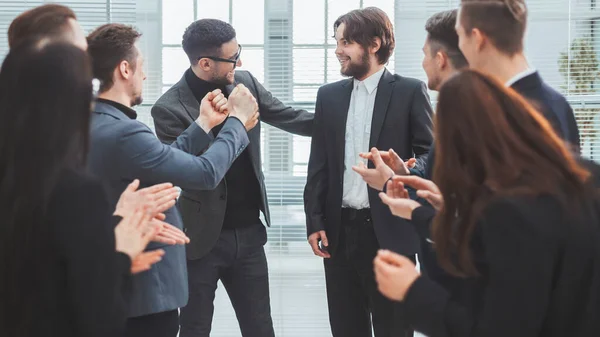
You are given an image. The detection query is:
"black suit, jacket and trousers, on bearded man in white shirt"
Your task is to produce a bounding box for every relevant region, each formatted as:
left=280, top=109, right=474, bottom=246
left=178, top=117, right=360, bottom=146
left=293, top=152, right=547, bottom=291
left=304, top=70, right=432, bottom=337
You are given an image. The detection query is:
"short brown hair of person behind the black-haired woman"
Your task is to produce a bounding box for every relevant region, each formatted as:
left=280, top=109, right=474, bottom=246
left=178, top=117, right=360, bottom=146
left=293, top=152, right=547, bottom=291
left=8, top=4, right=77, bottom=48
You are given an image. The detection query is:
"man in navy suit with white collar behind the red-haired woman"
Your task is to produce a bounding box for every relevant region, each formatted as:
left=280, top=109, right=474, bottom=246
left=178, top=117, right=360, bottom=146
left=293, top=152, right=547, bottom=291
left=456, top=0, right=580, bottom=152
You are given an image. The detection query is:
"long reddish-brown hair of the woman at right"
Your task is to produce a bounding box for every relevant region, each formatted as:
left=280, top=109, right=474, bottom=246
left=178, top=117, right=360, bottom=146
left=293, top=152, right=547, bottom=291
left=432, top=70, right=590, bottom=276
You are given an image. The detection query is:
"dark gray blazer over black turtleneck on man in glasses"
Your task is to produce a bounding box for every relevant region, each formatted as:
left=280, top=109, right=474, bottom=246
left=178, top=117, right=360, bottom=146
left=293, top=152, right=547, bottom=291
left=152, top=70, right=314, bottom=259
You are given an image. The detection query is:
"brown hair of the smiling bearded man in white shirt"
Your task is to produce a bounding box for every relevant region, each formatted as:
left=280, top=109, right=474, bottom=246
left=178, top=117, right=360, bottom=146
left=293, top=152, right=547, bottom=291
left=333, top=7, right=396, bottom=64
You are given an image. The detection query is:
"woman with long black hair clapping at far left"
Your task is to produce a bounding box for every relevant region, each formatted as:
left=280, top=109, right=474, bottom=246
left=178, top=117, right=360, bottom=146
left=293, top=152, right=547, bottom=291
left=0, top=40, right=172, bottom=337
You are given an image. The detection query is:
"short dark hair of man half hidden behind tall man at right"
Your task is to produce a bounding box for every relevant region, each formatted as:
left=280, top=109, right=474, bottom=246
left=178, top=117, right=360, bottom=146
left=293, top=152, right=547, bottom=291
left=425, top=9, right=468, bottom=69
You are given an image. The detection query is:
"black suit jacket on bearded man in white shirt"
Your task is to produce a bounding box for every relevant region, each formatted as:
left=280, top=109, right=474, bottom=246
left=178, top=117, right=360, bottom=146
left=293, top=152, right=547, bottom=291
left=304, top=70, right=432, bottom=255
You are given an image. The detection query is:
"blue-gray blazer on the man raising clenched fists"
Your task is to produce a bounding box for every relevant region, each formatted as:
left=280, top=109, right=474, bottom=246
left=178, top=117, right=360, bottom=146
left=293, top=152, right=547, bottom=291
left=88, top=102, right=248, bottom=317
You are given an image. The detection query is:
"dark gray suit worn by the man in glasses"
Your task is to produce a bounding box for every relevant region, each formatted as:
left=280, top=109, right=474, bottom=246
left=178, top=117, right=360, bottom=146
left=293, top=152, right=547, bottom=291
left=152, top=70, right=313, bottom=337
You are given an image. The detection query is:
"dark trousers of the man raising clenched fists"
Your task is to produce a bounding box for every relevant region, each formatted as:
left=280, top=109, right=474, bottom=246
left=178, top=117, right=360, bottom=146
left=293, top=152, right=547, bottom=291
left=123, top=310, right=179, bottom=337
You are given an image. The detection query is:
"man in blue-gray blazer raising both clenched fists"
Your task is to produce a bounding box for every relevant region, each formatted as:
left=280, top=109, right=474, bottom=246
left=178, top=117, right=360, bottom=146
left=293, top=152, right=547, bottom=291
left=88, top=24, right=258, bottom=337
